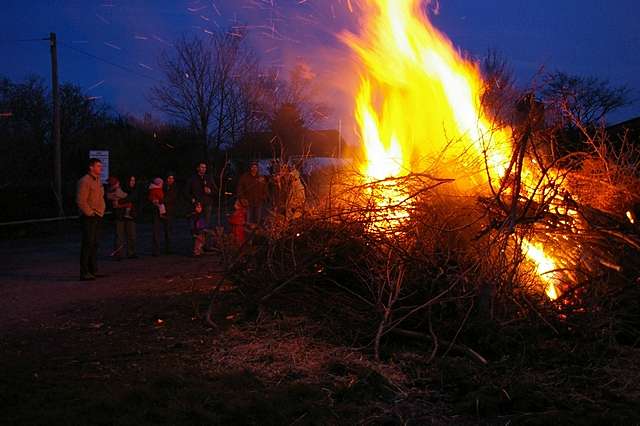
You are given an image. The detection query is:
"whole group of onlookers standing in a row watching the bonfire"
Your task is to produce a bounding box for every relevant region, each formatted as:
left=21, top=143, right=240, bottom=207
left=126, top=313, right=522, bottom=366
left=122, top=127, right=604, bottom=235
left=76, top=158, right=305, bottom=281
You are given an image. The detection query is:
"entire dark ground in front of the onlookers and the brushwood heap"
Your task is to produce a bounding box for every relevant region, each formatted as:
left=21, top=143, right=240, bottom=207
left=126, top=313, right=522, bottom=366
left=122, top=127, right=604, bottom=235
left=0, top=220, right=640, bottom=425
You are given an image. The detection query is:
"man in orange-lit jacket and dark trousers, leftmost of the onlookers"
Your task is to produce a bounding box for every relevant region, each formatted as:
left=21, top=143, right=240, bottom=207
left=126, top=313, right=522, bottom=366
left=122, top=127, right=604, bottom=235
left=76, top=158, right=105, bottom=281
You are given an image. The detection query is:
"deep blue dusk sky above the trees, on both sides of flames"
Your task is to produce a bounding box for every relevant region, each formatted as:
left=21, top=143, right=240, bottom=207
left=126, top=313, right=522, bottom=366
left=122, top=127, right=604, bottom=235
left=0, top=0, right=640, bottom=127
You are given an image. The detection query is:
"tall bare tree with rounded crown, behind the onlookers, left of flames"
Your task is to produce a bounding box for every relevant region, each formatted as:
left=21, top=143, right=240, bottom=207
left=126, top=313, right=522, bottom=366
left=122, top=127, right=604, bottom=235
left=151, top=27, right=278, bottom=166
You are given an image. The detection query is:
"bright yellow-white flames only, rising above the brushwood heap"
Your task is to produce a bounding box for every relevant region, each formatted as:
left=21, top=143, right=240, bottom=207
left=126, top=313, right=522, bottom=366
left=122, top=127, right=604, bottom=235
left=343, top=0, right=559, bottom=300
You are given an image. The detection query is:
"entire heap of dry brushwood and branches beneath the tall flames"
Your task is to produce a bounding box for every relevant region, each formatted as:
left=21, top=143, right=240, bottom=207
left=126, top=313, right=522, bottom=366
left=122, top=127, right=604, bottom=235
left=208, top=113, right=640, bottom=363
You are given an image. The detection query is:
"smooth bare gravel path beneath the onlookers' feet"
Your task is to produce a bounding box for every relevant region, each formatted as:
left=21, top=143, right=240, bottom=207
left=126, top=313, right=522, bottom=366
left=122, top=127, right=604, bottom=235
left=0, top=221, right=216, bottom=331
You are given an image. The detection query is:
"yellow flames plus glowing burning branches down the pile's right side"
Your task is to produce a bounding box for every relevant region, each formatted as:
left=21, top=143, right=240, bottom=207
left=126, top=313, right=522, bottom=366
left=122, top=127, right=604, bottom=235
left=343, top=0, right=633, bottom=300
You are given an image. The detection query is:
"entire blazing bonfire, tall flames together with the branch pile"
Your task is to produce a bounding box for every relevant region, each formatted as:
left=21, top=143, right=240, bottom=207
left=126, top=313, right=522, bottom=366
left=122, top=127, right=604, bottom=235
left=215, top=0, right=640, bottom=362
